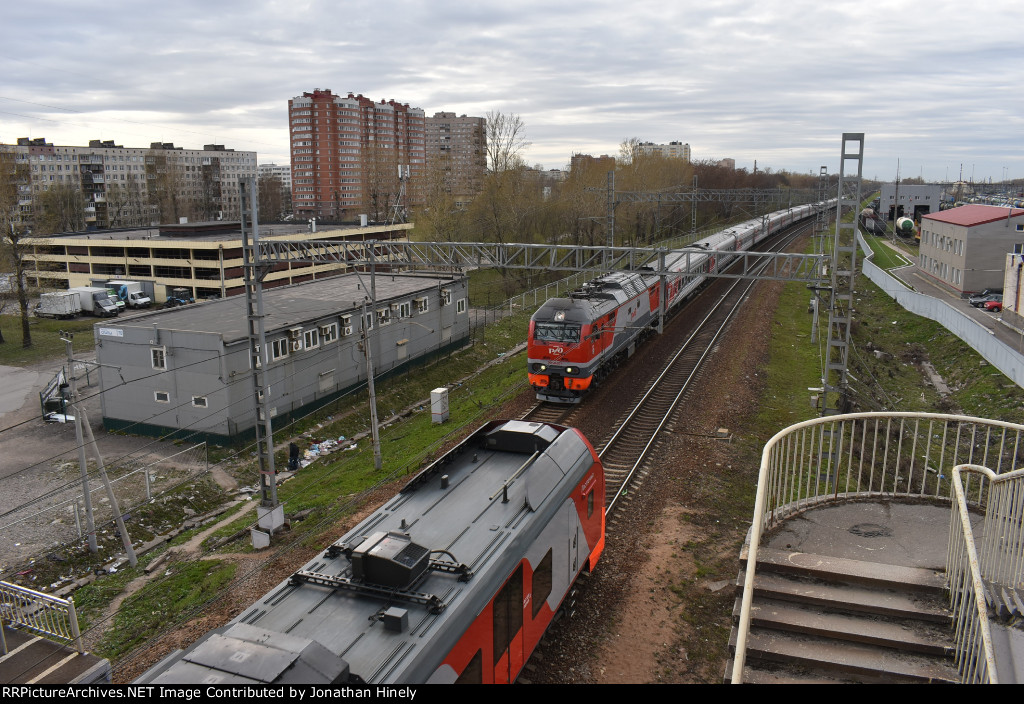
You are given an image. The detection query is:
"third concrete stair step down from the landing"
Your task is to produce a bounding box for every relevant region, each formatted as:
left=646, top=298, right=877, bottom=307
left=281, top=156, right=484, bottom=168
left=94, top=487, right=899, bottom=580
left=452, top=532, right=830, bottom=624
left=751, top=603, right=953, bottom=656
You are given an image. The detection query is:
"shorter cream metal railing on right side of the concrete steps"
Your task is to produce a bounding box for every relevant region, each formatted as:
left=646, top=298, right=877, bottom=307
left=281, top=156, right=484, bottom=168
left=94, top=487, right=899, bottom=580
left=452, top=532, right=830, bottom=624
left=946, top=465, right=1024, bottom=685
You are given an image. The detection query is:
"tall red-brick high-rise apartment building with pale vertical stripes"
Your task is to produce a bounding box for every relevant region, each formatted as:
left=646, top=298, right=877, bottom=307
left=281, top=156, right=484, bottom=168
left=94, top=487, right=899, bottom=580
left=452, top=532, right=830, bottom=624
left=288, top=89, right=426, bottom=220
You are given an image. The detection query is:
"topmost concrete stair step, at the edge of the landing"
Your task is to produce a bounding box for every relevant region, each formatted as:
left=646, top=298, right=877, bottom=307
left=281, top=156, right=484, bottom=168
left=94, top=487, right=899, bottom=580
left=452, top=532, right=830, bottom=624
left=739, top=546, right=945, bottom=593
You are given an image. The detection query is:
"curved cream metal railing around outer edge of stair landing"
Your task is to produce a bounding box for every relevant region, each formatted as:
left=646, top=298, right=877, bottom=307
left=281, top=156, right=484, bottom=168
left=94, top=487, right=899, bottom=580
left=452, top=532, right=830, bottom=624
left=731, top=412, right=1024, bottom=684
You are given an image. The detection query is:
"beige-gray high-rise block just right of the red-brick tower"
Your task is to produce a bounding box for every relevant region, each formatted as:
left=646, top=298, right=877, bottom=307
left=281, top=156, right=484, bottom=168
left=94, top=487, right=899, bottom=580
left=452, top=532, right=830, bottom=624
left=426, top=113, right=487, bottom=207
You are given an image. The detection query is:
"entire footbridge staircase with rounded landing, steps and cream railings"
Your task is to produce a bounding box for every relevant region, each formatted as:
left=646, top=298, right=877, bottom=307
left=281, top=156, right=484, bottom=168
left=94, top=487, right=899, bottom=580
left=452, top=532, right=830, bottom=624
left=726, top=413, right=1024, bottom=684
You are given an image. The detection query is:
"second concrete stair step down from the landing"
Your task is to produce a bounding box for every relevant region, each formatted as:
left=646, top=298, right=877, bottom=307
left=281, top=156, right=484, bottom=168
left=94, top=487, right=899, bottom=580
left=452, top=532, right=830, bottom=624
left=737, top=572, right=950, bottom=624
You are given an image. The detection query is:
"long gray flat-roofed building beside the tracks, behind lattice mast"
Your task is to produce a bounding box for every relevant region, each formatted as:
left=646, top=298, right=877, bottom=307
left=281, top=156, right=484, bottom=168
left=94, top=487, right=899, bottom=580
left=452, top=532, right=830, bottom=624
left=94, top=273, right=470, bottom=442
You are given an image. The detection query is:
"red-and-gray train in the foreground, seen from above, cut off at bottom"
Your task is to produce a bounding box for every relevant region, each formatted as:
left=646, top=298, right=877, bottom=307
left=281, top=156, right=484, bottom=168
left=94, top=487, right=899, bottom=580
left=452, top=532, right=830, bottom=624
left=138, top=421, right=604, bottom=685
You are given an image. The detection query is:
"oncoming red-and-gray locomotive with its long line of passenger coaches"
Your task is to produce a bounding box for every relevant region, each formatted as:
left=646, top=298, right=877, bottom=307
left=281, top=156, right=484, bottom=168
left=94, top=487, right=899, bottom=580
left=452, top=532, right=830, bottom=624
left=526, top=205, right=817, bottom=403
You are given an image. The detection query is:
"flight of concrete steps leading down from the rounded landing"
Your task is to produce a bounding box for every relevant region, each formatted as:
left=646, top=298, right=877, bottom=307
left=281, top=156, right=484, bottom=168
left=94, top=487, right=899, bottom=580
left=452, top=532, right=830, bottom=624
left=725, top=547, right=959, bottom=684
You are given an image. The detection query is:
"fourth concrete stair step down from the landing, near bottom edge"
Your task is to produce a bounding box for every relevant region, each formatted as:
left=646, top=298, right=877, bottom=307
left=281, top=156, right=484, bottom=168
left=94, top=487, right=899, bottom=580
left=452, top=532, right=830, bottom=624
left=730, top=628, right=959, bottom=683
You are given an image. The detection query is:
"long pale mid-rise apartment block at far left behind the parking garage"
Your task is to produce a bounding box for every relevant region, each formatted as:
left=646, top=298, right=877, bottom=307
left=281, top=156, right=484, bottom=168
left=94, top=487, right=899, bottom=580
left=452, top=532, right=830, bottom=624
left=2, top=137, right=256, bottom=229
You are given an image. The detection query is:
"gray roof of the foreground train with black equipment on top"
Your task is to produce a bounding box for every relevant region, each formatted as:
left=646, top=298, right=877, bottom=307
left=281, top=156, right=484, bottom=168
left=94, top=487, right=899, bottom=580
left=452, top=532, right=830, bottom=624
left=138, top=421, right=596, bottom=685
